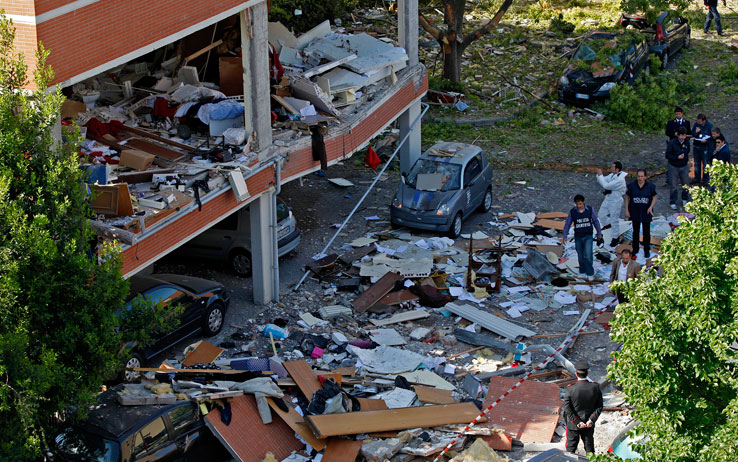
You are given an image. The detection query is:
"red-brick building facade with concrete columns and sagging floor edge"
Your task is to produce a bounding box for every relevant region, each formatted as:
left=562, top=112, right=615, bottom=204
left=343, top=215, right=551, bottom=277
left=12, top=0, right=428, bottom=303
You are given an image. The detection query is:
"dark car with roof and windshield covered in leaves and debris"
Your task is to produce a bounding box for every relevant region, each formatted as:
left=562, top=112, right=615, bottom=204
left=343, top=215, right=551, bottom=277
left=558, top=32, right=650, bottom=106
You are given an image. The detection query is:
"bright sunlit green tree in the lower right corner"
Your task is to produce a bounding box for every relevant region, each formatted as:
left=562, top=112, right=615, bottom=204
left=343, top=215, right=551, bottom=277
left=598, top=161, right=738, bottom=462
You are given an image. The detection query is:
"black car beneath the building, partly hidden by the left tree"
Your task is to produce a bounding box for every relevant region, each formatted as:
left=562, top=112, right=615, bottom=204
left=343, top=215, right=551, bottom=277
left=120, top=274, right=231, bottom=382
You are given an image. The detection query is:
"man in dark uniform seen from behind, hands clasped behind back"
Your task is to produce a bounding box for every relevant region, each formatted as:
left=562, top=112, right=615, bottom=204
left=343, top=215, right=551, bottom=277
left=563, top=359, right=603, bottom=454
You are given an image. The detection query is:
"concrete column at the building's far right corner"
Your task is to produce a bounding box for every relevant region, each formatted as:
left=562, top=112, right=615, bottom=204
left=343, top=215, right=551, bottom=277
left=398, top=0, right=421, bottom=173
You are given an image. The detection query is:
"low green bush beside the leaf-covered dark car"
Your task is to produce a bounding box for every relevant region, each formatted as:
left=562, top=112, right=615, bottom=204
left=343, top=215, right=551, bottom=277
left=605, top=76, right=684, bottom=130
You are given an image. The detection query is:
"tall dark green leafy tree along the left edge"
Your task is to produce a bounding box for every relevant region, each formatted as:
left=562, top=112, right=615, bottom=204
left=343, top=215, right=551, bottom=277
left=0, top=12, right=171, bottom=461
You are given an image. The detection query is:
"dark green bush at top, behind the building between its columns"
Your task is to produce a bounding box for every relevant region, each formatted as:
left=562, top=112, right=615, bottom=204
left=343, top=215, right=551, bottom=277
left=269, top=0, right=360, bottom=34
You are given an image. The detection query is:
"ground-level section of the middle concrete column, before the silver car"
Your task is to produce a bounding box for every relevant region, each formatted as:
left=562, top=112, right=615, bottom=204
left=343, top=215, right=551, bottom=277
left=249, top=193, right=279, bottom=305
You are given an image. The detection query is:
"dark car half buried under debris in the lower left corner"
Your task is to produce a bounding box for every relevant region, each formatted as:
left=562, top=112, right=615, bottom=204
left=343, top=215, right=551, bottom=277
left=47, top=389, right=228, bottom=462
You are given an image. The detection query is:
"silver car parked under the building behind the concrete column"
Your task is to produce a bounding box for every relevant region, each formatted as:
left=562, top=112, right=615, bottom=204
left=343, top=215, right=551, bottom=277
left=177, top=199, right=300, bottom=277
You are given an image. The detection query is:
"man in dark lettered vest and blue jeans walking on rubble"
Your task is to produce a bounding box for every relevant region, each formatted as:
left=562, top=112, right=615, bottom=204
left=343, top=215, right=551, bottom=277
left=561, top=194, right=602, bottom=281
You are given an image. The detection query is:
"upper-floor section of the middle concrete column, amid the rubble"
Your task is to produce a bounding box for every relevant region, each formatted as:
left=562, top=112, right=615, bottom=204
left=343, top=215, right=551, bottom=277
left=240, top=2, right=272, bottom=155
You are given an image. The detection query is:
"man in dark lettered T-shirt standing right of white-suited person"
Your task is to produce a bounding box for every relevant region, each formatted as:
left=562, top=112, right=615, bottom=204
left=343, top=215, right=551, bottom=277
left=625, top=169, right=659, bottom=260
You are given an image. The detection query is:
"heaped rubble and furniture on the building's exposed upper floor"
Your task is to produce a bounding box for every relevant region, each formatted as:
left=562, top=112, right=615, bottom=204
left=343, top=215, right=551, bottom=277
left=62, top=14, right=408, bottom=245
